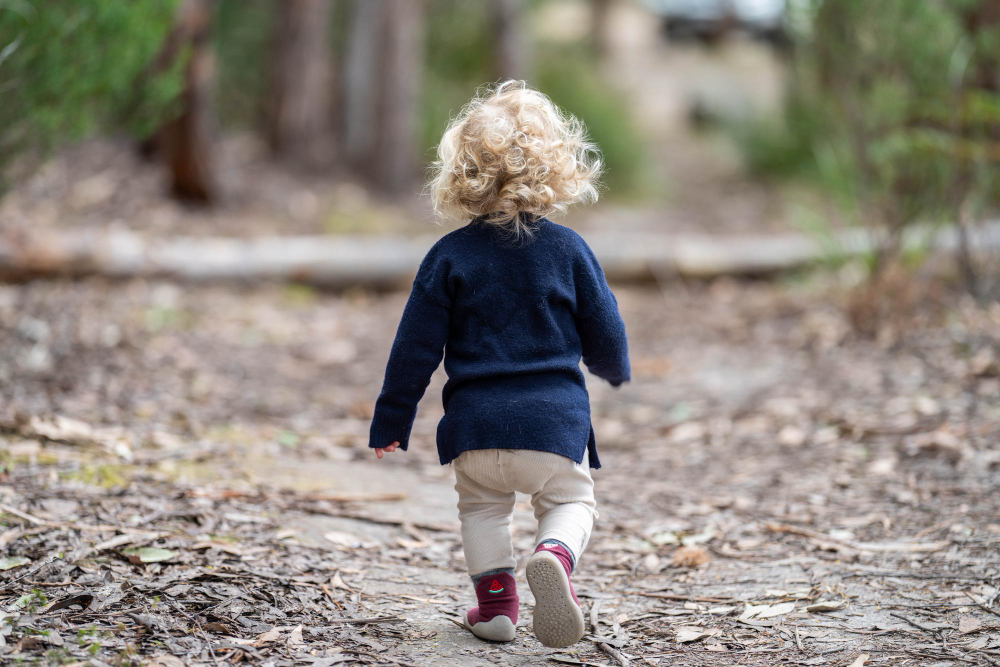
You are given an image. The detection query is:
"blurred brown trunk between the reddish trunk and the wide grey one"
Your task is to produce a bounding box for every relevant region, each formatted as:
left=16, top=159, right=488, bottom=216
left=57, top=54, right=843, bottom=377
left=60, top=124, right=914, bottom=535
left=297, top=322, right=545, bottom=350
left=267, top=0, right=333, bottom=165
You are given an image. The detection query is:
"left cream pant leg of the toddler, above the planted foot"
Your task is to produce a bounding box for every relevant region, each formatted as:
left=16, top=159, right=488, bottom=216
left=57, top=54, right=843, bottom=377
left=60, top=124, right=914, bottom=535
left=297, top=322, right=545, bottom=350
left=454, top=449, right=517, bottom=577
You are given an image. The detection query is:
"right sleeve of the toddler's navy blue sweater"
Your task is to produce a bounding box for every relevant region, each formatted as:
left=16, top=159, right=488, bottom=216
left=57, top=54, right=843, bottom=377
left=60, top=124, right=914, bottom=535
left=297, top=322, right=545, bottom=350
left=574, top=239, right=631, bottom=387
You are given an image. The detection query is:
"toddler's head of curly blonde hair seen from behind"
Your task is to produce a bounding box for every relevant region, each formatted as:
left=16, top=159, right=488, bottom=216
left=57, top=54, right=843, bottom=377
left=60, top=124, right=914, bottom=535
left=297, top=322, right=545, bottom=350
left=430, top=81, right=601, bottom=234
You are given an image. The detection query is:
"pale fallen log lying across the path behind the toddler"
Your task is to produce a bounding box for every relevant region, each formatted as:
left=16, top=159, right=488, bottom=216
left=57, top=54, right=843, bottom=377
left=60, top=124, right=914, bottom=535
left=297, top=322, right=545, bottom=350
left=0, top=220, right=1000, bottom=287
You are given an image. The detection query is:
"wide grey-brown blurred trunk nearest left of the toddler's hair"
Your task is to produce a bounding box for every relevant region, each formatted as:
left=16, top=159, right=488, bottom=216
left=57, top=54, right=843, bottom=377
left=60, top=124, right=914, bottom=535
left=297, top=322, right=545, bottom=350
left=343, top=0, right=425, bottom=195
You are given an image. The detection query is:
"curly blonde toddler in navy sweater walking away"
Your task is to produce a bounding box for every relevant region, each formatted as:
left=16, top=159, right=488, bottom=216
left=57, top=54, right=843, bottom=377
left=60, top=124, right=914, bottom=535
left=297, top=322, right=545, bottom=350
left=369, top=81, right=629, bottom=647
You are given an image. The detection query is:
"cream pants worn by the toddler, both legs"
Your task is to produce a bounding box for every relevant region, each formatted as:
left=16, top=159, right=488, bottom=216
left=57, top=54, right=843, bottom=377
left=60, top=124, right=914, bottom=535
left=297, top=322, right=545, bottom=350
left=454, top=449, right=597, bottom=575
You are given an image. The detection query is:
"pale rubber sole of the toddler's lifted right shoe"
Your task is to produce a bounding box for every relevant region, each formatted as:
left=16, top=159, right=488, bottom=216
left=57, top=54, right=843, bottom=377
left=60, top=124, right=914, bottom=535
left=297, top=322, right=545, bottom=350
left=526, top=551, right=584, bottom=648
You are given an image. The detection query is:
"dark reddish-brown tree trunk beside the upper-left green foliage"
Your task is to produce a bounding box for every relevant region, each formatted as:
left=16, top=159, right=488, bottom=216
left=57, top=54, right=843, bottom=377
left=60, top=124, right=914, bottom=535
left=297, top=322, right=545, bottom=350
left=160, top=0, right=217, bottom=204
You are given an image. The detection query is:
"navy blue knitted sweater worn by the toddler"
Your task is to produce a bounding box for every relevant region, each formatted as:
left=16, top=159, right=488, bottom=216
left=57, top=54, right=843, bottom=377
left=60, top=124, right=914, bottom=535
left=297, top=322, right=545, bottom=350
left=369, top=219, right=629, bottom=468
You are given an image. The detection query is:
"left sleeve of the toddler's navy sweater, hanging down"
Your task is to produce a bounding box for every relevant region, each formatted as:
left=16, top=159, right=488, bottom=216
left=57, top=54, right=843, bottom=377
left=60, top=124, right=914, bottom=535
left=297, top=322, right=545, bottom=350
left=368, top=255, right=451, bottom=450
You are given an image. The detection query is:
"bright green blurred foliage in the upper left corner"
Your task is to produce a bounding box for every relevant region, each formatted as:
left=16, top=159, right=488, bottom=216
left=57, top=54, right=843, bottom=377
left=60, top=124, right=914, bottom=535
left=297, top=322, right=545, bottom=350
left=0, top=0, right=180, bottom=156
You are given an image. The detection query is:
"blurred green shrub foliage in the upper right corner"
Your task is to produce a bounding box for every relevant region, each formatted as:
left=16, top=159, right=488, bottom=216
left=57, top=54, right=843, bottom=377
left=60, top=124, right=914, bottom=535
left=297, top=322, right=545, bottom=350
left=739, top=0, right=1000, bottom=239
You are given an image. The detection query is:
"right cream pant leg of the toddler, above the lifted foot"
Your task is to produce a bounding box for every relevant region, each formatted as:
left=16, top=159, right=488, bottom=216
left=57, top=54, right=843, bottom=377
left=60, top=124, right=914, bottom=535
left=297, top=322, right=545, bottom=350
left=531, top=454, right=597, bottom=563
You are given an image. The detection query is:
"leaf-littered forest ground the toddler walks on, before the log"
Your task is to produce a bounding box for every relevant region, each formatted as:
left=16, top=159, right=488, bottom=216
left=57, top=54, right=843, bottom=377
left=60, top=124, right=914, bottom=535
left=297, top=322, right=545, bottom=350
left=0, top=280, right=1000, bottom=665
